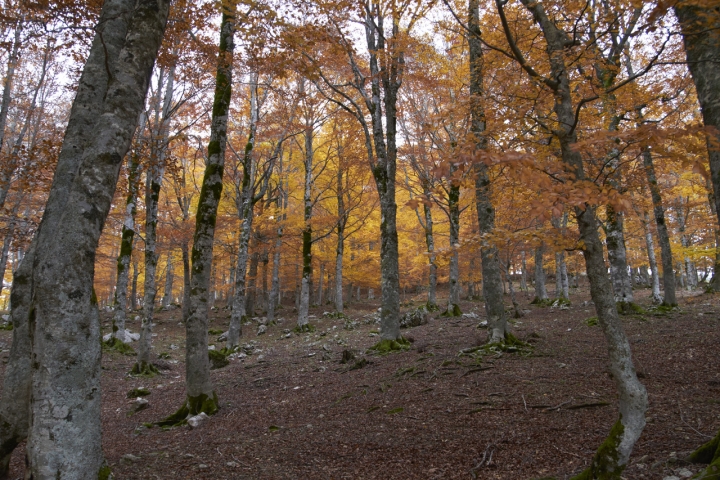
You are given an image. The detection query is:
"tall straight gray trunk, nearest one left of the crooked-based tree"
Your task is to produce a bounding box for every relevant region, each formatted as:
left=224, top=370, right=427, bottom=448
left=468, top=0, right=509, bottom=343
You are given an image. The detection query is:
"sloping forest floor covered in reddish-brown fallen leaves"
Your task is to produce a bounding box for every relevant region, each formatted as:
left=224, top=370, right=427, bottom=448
left=0, top=291, right=720, bottom=479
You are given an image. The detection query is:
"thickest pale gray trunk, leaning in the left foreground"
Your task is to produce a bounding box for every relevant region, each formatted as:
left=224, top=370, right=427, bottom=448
left=0, top=0, right=168, bottom=479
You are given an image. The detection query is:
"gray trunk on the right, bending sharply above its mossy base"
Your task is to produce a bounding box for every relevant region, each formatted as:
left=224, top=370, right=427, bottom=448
left=504, top=0, right=648, bottom=472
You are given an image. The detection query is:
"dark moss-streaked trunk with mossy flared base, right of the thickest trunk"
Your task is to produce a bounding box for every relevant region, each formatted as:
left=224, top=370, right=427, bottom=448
left=167, top=3, right=235, bottom=423
